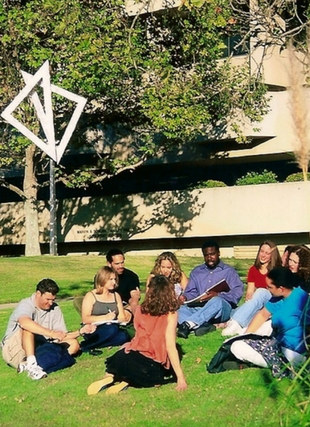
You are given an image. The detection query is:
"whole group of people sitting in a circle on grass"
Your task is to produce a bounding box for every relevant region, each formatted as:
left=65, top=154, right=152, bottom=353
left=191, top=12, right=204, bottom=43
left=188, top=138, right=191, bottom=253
left=2, top=240, right=310, bottom=395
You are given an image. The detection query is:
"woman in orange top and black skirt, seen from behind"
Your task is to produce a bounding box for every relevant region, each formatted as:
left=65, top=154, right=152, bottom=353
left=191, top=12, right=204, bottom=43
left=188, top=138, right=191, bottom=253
left=87, top=276, right=187, bottom=395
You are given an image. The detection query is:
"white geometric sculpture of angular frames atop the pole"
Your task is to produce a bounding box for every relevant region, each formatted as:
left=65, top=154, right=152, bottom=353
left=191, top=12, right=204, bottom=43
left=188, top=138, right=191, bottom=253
left=1, top=61, right=87, bottom=163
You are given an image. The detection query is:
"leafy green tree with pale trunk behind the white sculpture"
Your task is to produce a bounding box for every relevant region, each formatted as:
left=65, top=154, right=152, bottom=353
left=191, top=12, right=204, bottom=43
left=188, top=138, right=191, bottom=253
left=0, top=0, right=267, bottom=255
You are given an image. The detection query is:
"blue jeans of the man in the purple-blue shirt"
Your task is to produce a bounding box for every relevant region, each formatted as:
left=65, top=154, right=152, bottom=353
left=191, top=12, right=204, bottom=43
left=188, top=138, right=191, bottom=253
left=178, top=297, right=231, bottom=326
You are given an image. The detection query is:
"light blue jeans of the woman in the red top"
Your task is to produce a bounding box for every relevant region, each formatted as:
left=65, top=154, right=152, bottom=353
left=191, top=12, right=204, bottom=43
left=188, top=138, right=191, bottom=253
left=232, top=288, right=272, bottom=328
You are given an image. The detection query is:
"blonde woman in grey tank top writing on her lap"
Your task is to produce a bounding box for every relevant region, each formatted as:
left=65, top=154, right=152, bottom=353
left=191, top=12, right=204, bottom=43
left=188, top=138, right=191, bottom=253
left=81, top=266, right=130, bottom=354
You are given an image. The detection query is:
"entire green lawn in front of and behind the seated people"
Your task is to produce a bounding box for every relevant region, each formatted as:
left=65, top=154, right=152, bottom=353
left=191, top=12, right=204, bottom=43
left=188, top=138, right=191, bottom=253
left=0, top=256, right=302, bottom=427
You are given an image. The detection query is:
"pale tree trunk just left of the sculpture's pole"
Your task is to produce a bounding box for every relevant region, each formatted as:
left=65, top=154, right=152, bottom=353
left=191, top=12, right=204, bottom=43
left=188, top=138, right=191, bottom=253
left=24, top=144, right=41, bottom=256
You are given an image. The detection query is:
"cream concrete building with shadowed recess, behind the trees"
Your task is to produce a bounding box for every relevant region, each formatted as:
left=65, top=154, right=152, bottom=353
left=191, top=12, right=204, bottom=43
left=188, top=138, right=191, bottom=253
left=0, top=0, right=310, bottom=256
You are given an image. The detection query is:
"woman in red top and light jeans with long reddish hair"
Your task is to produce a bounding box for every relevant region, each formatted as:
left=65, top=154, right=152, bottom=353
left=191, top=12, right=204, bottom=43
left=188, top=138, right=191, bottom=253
left=222, top=240, right=282, bottom=337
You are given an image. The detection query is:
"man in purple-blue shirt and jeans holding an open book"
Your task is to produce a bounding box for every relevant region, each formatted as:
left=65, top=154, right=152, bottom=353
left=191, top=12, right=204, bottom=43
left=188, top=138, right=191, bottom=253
left=177, top=240, right=243, bottom=338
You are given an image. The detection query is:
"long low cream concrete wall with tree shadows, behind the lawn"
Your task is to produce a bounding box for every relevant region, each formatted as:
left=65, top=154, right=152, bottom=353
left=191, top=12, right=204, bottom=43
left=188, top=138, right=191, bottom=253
left=0, top=182, right=310, bottom=256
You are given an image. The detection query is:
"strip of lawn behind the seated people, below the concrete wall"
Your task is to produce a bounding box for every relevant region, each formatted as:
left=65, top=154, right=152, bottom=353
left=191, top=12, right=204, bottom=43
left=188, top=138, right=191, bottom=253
left=0, top=255, right=252, bottom=304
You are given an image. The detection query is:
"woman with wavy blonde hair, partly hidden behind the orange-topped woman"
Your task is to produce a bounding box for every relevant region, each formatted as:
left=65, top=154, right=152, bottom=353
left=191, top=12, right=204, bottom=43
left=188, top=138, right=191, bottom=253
left=146, top=251, right=188, bottom=297
